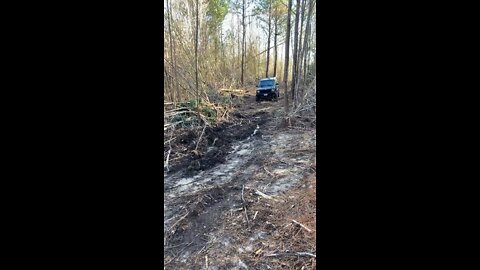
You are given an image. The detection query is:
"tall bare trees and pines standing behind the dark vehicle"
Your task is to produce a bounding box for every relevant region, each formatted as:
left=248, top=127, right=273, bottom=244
left=164, top=0, right=316, bottom=112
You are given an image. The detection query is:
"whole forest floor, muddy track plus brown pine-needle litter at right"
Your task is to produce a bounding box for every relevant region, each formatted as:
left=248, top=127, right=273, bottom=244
left=164, top=89, right=316, bottom=270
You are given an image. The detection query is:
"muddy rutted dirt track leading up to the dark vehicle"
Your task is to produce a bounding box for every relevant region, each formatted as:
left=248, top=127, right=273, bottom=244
left=164, top=89, right=316, bottom=269
